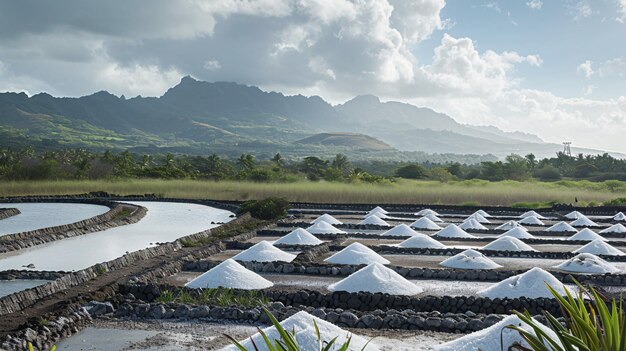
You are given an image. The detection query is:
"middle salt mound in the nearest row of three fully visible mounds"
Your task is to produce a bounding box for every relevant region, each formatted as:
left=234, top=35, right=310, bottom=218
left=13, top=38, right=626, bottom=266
left=328, top=263, right=423, bottom=296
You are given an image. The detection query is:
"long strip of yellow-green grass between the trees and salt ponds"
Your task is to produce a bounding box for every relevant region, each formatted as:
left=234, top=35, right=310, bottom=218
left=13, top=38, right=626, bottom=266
left=0, top=180, right=626, bottom=206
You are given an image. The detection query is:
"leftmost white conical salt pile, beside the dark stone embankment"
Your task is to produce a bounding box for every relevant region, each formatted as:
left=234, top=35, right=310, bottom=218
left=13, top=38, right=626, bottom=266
left=185, top=258, right=274, bottom=290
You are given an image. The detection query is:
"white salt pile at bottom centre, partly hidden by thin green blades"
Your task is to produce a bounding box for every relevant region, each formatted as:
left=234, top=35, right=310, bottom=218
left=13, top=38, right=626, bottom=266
left=223, top=311, right=380, bottom=351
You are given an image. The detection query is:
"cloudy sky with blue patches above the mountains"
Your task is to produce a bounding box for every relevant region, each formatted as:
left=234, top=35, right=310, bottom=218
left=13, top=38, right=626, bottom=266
left=0, top=0, right=626, bottom=152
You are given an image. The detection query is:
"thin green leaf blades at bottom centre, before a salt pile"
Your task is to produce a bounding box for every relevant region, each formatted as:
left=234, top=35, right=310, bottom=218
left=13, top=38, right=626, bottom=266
left=225, top=307, right=371, bottom=351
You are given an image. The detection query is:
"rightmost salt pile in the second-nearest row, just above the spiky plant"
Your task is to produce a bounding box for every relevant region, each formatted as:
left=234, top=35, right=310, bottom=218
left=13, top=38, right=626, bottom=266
left=478, top=267, right=565, bottom=299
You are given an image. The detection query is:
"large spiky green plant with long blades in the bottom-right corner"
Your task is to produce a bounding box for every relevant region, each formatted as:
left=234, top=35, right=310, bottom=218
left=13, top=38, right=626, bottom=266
left=509, top=282, right=626, bottom=351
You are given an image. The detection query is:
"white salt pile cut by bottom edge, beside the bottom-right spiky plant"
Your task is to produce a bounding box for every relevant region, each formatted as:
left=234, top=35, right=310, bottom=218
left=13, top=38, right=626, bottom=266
left=434, top=315, right=560, bottom=351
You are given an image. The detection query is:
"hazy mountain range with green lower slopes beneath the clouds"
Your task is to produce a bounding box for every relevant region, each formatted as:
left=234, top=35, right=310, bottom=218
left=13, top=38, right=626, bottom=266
left=0, top=77, right=623, bottom=158
